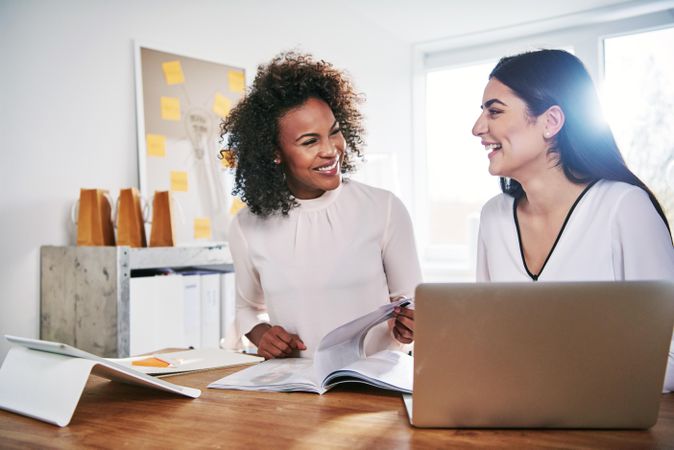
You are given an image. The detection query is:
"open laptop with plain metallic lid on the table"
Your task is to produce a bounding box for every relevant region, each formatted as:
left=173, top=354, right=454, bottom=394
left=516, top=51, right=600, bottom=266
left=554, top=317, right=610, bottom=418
left=405, top=281, right=674, bottom=429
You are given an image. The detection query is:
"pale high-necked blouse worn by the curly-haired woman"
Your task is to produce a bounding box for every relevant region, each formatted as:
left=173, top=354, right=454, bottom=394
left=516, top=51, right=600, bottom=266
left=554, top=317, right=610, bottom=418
left=229, top=180, right=421, bottom=357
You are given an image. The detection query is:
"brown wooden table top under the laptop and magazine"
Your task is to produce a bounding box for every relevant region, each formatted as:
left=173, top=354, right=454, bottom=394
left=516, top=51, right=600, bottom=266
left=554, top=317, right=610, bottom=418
left=0, top=368, right=674, bottom=449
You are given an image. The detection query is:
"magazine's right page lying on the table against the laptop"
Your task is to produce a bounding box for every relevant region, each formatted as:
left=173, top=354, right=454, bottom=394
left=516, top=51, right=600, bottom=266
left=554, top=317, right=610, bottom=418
left=323, top=350, right=414, bottom=394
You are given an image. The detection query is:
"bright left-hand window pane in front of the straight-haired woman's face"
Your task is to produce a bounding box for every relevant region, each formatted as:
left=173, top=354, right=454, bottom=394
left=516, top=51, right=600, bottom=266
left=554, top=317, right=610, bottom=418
left=426, top=61, right=500, bottom=270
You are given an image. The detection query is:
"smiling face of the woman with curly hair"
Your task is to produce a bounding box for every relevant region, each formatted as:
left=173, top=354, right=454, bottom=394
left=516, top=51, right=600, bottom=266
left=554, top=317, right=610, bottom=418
left=278, top=98, right=346, bottom=199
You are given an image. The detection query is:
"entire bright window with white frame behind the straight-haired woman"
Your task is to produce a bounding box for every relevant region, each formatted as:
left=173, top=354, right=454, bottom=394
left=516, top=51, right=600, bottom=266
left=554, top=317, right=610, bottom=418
left=413, top=4, right=674, bottom=281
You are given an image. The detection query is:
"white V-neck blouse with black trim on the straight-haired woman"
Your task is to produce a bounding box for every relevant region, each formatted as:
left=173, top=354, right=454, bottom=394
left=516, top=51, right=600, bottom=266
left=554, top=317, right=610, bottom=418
left=477, top=180, right=674, bottom=391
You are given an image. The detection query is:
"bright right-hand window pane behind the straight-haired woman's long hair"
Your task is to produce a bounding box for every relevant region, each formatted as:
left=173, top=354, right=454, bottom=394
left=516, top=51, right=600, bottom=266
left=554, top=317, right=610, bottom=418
left=602, top=28, right=674, bottom=228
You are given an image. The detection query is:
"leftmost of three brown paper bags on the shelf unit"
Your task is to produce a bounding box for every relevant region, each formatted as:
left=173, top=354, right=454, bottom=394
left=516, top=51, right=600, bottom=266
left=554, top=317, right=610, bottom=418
left=77, top=189, right=115, bottom=245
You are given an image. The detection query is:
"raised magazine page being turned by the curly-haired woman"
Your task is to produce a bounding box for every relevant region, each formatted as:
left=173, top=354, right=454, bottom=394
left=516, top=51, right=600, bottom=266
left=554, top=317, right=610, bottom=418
left=314, top=298, right=412, bottom=380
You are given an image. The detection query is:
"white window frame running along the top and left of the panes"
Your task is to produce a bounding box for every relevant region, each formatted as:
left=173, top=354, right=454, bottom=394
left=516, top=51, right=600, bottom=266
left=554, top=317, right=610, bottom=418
left=412, top=1, right=674, bottom=281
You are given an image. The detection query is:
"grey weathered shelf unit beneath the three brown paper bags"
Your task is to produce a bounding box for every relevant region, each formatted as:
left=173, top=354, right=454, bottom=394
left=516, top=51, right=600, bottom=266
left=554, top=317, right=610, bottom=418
left=40, top=243, right=234, bottom=358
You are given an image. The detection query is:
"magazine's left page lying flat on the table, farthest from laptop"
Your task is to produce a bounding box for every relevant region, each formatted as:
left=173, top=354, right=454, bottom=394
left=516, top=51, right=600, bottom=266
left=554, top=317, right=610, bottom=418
left=208, top=358, right=324, bottom=393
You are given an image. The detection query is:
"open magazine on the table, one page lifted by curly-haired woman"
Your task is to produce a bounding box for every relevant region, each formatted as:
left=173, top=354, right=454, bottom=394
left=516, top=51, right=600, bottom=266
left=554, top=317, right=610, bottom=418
left=208, top=298, right=414, bottom=394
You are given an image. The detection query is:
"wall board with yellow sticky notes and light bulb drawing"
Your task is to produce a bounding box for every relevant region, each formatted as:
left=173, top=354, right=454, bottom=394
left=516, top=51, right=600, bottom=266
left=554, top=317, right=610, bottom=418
left=135, top=44, right=245, bottom=246
